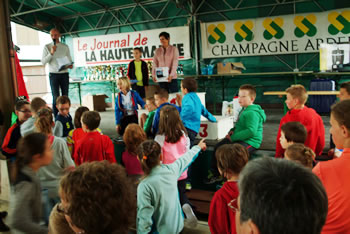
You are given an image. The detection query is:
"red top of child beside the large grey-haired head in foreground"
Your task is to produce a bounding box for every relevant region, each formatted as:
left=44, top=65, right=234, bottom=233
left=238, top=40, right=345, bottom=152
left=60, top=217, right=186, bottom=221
left=208, top=181, right=239, bottom=234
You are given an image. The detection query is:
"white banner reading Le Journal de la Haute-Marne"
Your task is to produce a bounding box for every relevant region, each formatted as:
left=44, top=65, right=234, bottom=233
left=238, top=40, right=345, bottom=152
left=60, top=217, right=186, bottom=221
left=73, top=26, right=191, bottom=67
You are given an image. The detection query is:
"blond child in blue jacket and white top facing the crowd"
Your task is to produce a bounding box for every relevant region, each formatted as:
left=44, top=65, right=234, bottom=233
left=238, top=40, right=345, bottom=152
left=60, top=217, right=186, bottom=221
left=115, top=77, right=145, bottom=136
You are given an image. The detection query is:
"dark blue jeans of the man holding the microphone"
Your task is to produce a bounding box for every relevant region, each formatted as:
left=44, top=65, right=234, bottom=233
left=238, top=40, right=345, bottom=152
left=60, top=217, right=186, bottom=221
left=49, top=73, right=69, bottom=118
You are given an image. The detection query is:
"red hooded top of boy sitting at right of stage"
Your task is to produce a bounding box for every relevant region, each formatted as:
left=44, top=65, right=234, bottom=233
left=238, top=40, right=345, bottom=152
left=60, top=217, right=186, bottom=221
left=275, top=106, right=325, bottom=158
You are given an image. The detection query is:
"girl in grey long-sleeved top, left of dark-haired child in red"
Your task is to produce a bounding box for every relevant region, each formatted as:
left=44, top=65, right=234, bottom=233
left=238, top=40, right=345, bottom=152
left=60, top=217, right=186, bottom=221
left=35, top=108, right=75, bottom=218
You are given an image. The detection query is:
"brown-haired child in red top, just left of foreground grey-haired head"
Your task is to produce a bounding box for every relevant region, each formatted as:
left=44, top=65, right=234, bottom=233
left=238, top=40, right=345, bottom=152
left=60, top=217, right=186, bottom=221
left=208, top=144, right=249, bottom=234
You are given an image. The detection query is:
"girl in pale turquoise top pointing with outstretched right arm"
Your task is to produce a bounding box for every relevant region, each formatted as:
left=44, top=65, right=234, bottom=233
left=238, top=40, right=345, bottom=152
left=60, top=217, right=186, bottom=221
left=137, top=139, right=206, bottom=233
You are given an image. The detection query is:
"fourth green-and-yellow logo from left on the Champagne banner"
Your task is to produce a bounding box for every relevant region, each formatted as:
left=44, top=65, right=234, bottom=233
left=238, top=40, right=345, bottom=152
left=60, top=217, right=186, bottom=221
left=294, top=14, right=317, bottom=37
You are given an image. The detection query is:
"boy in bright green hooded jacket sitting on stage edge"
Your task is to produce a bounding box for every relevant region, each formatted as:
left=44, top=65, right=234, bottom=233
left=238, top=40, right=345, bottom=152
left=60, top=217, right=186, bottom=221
left=204, top=84, right=266, bottom=184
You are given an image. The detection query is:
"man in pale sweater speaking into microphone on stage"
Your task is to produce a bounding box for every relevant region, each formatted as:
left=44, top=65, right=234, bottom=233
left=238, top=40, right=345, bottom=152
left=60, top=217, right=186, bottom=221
left=41, top=28, right=73, bottom=118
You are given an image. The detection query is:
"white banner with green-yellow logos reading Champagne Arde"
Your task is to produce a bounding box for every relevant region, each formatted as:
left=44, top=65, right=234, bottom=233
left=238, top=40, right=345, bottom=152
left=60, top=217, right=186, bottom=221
left=201, top=8, right=350, bottom=58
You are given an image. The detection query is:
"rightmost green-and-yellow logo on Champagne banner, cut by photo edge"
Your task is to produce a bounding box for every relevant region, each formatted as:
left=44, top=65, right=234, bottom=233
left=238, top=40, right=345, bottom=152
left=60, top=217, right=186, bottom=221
left=328, top=10, right=350, bottom=35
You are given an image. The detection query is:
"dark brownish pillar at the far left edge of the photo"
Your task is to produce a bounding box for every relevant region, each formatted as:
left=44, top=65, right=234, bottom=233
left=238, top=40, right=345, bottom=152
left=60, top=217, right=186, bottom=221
left=0, top=0, right=16, bottom=142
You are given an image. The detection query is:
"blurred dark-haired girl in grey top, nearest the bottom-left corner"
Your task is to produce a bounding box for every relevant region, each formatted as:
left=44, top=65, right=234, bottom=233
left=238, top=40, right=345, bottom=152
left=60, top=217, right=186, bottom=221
left=9, top=133, right=53, bottom=234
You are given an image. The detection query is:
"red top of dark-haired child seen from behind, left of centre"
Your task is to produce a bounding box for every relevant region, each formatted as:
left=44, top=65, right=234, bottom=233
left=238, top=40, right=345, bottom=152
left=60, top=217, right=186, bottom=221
left=73, top=132, right=116, bottom=166
